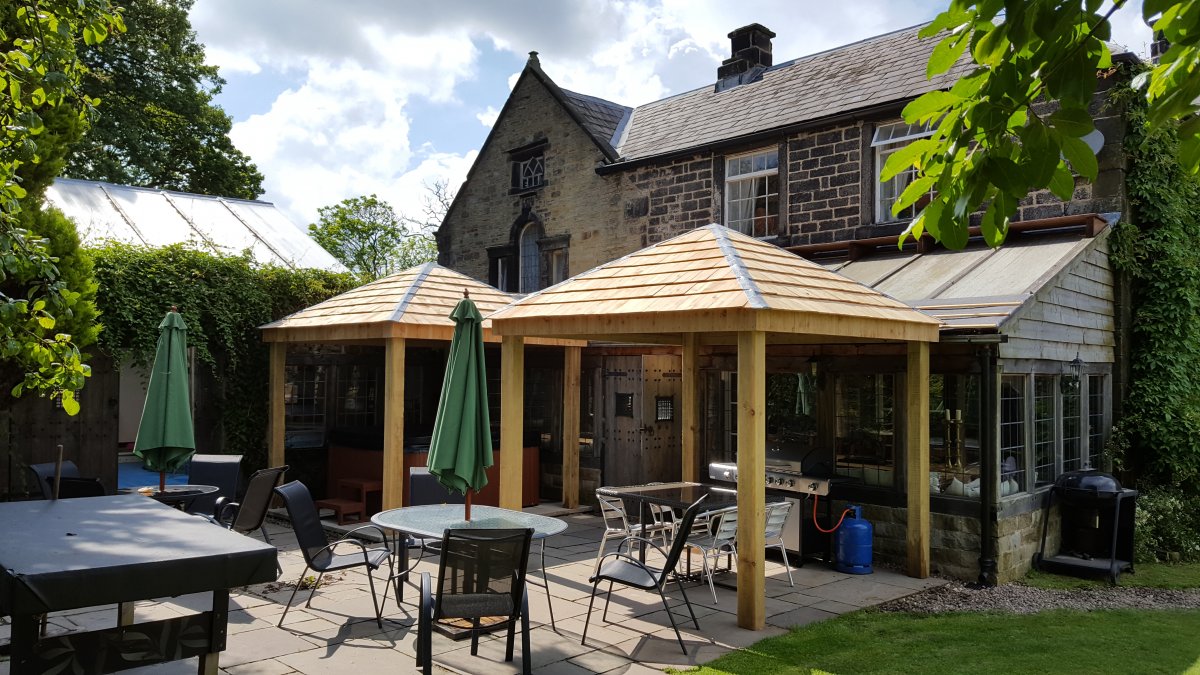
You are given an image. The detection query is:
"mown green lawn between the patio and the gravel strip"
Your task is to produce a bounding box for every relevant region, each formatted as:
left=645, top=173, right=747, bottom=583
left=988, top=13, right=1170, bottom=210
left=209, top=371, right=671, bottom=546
left=689, top=607, right=1200, bottom=675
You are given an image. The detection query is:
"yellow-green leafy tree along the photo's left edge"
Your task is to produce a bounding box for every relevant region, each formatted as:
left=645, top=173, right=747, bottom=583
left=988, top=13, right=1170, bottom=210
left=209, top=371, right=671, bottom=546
left=0, top=0, right=124, bottom=414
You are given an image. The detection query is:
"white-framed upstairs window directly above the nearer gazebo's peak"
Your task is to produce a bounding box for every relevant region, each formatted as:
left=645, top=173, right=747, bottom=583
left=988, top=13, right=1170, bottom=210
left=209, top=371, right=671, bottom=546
left=725, top=147, right=781, bottom=238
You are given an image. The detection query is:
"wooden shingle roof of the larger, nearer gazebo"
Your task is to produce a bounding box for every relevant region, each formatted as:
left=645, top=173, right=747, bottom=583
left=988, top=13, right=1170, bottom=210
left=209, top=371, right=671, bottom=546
left=491, top=225, right=937, bottom=340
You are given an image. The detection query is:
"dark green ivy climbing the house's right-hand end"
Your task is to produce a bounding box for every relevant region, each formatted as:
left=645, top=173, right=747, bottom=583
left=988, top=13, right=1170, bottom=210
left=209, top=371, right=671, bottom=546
left=1111, top=74, right=1200, bottom=492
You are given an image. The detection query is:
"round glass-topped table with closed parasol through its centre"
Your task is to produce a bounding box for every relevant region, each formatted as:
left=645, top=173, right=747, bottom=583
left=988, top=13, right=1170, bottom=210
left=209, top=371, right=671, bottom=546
left=371, top=504, right=566, bottom=632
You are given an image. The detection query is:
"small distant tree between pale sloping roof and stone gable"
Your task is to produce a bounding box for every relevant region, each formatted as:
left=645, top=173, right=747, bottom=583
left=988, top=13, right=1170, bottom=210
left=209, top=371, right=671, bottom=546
left=308, top=195, right=437, bottom=281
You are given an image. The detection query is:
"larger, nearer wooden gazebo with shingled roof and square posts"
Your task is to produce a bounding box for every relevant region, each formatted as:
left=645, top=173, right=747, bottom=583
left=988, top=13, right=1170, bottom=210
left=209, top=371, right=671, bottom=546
left=491, top=225, right=938, bottom=631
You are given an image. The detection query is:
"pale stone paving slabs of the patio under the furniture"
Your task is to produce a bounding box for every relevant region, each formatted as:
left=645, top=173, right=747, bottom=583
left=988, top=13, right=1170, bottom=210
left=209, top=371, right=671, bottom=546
left=0, top=506, right=943, bottom=675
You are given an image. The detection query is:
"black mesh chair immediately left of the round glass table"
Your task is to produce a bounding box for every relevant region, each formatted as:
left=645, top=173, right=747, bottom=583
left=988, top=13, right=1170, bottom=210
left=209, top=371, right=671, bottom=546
left=275, top=480, right=395, bottom=628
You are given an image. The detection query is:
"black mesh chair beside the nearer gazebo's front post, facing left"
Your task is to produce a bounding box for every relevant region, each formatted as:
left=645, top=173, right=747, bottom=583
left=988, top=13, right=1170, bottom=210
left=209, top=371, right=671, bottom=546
left=580, top=495, right=708, bottom=655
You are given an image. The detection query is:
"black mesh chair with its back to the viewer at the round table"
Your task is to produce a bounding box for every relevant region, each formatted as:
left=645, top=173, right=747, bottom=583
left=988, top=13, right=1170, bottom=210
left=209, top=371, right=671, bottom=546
left=416, top=528, right=533, bottom=675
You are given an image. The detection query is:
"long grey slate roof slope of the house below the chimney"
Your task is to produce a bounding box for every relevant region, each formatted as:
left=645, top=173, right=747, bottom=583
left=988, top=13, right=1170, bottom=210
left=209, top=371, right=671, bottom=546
left=617, top=25, right=971, bottom=160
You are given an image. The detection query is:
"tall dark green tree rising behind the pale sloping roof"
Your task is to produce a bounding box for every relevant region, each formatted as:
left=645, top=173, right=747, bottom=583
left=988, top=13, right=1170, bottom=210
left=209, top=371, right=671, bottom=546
left=64, top=0, right=263, bottom=199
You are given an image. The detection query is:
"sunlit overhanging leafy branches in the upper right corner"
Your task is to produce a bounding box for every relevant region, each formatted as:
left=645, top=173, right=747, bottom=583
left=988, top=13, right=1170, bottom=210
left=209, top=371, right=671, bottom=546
left=897, top=0, right=1200, bottom=249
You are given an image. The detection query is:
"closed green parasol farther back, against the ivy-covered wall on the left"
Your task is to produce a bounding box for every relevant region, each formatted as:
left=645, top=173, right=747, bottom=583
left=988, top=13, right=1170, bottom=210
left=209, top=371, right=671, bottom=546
left=133, top=307, right=196, bottom=491
